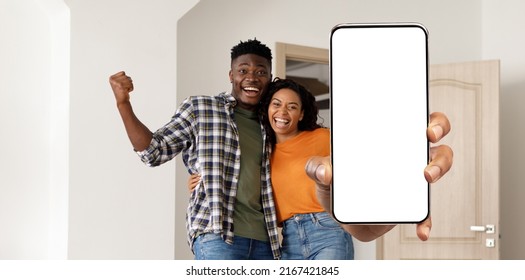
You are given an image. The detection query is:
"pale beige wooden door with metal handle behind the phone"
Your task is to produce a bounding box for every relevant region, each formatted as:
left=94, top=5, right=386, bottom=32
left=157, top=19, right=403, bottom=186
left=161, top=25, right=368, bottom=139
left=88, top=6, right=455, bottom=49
left=377, top=60, right=500, bottom=260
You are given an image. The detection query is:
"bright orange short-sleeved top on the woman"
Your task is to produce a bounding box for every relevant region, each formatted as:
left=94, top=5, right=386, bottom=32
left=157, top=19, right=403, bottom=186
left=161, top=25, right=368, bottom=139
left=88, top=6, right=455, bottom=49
left=271, top=128, right=330, bottom=225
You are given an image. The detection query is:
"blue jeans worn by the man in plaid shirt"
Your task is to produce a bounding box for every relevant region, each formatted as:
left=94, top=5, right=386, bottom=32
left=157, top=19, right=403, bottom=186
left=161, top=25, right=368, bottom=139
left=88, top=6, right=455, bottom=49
left=193, top=233, right=273, bottom=260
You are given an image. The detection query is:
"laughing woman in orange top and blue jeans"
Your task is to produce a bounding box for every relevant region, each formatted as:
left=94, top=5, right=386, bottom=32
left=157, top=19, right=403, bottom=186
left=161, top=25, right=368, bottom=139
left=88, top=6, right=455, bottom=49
left=188, top=78, right=354, bottom=260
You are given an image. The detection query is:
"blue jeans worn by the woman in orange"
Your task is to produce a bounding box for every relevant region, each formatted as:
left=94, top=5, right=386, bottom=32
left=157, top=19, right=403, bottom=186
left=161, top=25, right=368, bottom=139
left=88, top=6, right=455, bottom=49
left=281, top=212, right=354, bottom=260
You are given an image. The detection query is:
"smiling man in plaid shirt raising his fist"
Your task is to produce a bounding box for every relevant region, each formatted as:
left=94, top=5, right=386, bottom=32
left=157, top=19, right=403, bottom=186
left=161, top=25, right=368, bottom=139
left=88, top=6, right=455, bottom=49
left=110, top=39, right=280, bottom=260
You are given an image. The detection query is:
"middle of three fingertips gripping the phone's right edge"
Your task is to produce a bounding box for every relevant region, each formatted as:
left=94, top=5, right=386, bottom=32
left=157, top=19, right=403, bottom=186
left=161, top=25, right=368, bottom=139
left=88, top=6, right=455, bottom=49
left=424, top=145, right=454, bottom=183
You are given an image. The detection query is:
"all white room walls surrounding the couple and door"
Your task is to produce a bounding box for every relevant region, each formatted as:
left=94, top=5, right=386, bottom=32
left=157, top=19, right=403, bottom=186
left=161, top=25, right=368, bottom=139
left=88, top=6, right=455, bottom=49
left=0, top=0, right=525, bottom=259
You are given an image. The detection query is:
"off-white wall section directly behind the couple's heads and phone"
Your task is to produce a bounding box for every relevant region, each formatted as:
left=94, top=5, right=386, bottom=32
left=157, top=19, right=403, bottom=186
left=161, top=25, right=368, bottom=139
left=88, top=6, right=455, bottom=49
left=176, top=0, right=482, bottom=259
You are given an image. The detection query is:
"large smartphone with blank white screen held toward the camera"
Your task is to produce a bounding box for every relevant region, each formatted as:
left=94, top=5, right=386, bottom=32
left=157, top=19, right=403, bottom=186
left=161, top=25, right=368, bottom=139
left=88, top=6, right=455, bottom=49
left=330, top=23, right=430, bottom=224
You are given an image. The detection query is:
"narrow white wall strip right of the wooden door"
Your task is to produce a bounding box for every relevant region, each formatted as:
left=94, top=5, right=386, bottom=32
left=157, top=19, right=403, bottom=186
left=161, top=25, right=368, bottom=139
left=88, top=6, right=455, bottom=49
left=483, top=0, right=525, bottom=259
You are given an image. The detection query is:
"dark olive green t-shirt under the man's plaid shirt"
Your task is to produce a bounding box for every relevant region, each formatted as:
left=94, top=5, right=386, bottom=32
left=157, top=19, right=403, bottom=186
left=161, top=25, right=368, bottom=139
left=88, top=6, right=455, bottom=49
left=233, top=106, right=269, bottom=241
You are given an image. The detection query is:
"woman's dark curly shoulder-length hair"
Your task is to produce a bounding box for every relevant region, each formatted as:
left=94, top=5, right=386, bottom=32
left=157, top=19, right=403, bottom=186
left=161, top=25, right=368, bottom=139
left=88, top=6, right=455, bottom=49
left=259, top=77, right=323, bottom=147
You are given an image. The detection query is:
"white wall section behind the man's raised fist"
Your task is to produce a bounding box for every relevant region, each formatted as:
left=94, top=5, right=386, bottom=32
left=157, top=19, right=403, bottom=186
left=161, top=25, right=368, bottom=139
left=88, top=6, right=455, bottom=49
left=65, top=0, right=196, bottom=259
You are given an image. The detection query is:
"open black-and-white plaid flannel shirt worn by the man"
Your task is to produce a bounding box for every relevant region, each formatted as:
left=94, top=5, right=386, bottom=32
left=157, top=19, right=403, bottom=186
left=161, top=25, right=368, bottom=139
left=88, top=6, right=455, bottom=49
left=137, top=93, right=280, bottom=259
